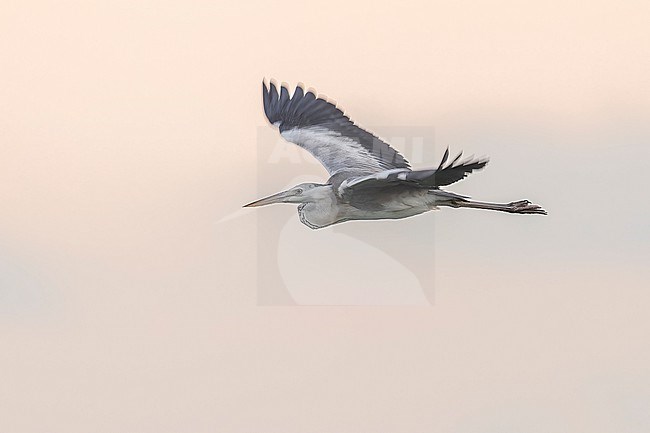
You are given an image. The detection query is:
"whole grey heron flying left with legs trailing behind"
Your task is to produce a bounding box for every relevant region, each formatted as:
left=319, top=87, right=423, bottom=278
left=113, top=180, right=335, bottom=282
left=244, top=81, right=546, bottom=229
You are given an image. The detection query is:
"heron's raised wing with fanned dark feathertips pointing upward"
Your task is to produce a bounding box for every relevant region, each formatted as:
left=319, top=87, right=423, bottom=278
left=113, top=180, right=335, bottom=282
left=262, top=81, right=409, bottom=177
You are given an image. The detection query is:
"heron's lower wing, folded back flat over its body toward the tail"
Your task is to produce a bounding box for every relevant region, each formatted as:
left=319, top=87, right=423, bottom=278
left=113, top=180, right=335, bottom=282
left=337, top=149, right=488, bottom=200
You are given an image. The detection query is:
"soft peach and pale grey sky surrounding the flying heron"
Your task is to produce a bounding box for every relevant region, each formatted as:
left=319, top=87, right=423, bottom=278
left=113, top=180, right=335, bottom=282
left=0, top=0, right=650, bottom=433
